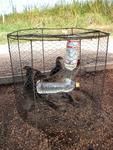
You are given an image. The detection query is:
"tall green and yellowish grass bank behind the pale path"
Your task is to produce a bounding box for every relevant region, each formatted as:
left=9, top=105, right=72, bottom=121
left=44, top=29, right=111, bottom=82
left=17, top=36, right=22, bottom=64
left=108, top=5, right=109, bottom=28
left=0, top=0, right=113, bottom=43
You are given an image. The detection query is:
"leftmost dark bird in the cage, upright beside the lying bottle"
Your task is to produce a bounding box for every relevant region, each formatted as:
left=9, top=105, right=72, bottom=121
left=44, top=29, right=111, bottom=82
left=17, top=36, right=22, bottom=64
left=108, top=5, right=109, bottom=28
left=17, top=66, right=36, bottom=121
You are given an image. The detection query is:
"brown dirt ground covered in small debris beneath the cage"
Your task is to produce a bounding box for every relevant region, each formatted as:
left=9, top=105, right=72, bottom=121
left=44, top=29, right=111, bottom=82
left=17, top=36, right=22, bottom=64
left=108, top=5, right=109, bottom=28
left=0, top=70, right=113, bottom=150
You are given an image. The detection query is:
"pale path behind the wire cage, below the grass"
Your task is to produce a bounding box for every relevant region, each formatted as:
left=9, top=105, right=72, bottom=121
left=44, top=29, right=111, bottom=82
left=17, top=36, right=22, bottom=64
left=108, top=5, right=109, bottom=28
left=0, top=37, right=113, bottom=77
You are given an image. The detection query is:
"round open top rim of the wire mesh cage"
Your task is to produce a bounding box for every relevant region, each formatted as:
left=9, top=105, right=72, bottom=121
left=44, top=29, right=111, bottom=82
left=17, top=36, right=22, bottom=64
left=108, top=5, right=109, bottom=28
left=7, top=27, right=110, bottom=41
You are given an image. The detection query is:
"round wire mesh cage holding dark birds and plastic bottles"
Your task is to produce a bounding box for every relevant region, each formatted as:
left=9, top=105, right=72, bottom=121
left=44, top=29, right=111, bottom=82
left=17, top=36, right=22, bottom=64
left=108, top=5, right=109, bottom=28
left=7, top=28, right=109, bottom=129
